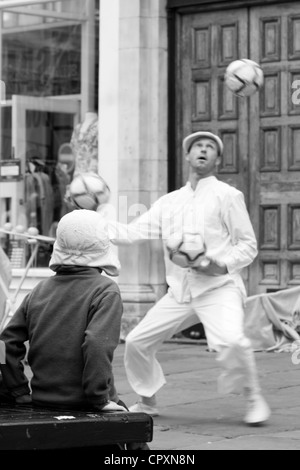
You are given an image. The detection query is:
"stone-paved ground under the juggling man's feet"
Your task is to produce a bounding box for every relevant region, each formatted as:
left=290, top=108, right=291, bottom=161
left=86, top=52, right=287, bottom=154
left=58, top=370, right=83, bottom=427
left=114, top=340, right=300, bottom=451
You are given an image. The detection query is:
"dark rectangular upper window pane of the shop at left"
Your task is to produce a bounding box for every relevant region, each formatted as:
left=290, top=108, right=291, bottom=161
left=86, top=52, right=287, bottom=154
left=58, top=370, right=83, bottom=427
left=2, top=25, right=81, bottom=99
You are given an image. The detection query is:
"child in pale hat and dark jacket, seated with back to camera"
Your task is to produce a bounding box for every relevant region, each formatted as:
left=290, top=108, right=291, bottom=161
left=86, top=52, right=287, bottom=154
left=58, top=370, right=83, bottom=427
left=0, top=210, right=125, bottom=411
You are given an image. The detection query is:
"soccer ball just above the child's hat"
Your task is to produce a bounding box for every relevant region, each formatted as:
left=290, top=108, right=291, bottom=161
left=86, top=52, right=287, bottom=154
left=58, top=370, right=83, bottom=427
left=69, top=173, right=110, bottom=210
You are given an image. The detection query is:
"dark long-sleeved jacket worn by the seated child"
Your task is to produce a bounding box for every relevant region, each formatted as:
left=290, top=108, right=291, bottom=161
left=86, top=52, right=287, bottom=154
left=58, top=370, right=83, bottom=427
left=0, top=266, right=123, bottom=409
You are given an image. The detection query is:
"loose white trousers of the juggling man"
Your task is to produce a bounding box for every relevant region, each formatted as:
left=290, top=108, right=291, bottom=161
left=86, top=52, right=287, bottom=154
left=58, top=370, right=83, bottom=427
left=124, top=283, right=260, bottom=397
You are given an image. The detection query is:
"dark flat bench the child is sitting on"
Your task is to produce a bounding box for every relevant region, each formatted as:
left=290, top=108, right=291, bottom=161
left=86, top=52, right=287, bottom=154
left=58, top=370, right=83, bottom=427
left=0, top=404, right=153, bottom=450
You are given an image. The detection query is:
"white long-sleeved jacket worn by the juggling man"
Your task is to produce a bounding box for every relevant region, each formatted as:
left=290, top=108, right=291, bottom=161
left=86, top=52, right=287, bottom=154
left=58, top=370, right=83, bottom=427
left=108, top=176, right=257, bottom=302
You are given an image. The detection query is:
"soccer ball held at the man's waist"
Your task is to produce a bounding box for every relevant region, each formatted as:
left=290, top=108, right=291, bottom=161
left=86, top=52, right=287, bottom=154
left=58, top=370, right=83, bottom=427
left=167, top=234, right=210, bottom=268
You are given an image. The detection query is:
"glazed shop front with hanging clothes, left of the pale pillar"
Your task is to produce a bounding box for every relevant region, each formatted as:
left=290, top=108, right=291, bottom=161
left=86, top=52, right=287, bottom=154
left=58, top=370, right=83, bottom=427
left=0, top=0, right=99, bottom=268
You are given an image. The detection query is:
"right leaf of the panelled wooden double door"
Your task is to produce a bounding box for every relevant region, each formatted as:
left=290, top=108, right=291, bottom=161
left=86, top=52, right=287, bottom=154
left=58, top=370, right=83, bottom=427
left=249, top=2, right=300, bottom=293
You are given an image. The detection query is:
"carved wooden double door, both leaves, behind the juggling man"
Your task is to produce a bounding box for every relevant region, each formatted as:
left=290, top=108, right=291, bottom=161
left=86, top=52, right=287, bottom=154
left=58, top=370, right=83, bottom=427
left=175, top=2, right=300, bottom=295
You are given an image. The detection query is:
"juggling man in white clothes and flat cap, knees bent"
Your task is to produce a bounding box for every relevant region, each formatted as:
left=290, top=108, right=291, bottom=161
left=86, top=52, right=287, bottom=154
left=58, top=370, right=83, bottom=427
left=106, top=132, right=270, bottom=425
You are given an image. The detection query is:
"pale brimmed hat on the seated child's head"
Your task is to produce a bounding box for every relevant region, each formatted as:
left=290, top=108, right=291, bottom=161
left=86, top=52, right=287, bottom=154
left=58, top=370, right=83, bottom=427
left=49, top=209, right=120, bottom=276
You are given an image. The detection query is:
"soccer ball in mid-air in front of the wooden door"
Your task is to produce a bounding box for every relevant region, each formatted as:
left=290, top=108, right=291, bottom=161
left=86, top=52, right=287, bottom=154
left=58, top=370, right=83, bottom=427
left=225, top=59, right=264, bottom=97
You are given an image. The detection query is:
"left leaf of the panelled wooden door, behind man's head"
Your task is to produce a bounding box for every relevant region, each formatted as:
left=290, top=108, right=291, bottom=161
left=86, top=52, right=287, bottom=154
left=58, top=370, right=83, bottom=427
left=176, top=9, right=249, bottom=283
